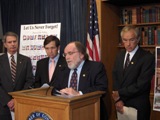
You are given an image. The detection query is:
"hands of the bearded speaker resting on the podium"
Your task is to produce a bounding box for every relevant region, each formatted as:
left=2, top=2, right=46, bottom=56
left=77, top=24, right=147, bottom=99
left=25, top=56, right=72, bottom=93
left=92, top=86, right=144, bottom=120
left=60, top=88, right=80, bottom=96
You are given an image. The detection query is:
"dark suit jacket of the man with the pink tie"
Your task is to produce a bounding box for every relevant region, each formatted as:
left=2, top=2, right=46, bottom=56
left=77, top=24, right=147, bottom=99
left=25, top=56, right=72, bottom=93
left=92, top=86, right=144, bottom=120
left=35, top=56, right=66, bottom=87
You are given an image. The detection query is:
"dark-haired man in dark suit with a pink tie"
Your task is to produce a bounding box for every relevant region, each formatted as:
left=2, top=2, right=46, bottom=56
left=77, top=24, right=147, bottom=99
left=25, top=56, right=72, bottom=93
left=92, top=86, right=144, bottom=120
left=35, top=35, right=66, bottom=87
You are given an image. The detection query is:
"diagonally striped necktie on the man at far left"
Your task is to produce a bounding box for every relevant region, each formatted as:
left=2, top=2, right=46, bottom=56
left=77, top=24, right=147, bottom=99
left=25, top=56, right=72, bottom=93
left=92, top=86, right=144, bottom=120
left=11, top=55, right=16, bottom=82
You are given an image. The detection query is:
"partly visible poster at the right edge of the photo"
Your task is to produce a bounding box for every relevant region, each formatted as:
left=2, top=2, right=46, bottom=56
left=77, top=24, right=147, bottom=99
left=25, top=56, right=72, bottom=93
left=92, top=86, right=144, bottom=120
left=153, top=47, right=160, bottom=111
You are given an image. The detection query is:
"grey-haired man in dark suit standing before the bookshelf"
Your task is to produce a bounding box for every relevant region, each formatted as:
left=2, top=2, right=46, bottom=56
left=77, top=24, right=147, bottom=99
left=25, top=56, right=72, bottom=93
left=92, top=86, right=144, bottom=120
left=112, top=26, right=155, bottom=120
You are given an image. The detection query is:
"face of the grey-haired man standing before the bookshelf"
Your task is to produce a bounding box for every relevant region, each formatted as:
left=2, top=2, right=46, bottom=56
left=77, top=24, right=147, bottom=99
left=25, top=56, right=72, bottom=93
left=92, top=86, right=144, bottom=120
left=122, top=30, right=139, bottom=52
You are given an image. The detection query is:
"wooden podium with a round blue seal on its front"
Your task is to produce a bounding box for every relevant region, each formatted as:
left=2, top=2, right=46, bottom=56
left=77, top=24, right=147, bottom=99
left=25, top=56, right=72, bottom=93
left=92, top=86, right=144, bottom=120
left=10, top=88, right=104, bottom=120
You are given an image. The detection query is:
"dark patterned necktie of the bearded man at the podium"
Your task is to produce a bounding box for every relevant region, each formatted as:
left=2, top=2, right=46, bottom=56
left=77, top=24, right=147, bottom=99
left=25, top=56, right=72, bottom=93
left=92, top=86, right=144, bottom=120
left=70, top=69, right=77, bottom=90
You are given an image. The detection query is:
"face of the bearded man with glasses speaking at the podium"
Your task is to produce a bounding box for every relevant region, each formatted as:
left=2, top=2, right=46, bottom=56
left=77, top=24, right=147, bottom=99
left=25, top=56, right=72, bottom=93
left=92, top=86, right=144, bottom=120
left=64, top=43, right=84, bottom=69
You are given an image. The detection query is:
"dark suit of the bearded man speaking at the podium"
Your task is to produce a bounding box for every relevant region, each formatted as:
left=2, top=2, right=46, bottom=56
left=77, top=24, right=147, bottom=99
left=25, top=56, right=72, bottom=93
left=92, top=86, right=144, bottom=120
left=54, top=60, right=108, bottom=120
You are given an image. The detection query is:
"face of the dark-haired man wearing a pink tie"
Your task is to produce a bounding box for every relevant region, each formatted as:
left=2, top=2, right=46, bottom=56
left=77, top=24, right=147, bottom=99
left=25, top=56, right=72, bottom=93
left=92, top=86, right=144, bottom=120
left=44, top=41, right=59, bottom=58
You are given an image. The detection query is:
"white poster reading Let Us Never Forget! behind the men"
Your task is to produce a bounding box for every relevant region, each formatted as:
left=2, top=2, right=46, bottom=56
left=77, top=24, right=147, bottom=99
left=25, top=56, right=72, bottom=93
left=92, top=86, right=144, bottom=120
left=19, top=23, right=61, bottom=75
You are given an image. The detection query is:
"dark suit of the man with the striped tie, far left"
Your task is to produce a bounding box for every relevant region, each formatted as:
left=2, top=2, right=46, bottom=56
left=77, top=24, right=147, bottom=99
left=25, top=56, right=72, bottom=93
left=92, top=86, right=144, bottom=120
left=0, top=54, right=34, bottom=120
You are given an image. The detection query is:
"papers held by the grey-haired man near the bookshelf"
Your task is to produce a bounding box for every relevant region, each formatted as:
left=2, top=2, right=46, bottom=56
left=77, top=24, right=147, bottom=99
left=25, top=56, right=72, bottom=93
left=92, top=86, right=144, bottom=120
left=117, top=106, right=137, bottom=120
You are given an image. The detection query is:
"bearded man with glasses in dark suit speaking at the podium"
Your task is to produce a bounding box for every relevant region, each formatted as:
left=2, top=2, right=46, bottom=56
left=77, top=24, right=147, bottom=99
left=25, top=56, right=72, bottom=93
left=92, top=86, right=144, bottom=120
left=54, top=41, right=107, bottom=120
